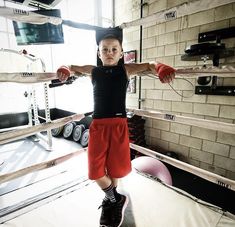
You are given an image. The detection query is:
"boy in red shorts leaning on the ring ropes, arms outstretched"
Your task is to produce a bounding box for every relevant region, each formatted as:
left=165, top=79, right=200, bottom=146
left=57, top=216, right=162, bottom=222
left=57, top=28, right=175, bottom=227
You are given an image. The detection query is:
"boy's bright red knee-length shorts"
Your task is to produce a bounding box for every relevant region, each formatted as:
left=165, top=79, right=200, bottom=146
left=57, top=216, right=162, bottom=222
left=88, top=118, right=131, bottom=180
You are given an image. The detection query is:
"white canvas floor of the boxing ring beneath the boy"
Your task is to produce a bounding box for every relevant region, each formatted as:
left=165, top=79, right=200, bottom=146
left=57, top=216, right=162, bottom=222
left=0, top=158, right=235, bottom=227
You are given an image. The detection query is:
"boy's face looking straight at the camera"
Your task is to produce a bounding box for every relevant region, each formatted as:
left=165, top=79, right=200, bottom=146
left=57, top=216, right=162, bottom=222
left=98, top=38, right=123, bottom=66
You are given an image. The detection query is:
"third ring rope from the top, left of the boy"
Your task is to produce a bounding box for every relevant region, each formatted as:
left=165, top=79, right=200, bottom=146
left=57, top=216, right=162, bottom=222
left=0, top=112, right=92, bottom=145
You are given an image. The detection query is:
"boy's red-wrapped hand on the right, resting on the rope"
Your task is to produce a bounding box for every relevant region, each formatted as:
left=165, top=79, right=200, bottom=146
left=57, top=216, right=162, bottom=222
left=152, top=63, right=175, bottom=83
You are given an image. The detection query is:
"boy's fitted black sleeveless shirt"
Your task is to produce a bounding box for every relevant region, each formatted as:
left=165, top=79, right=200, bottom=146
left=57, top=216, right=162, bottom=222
left=91, top=65, right=129, bottom=119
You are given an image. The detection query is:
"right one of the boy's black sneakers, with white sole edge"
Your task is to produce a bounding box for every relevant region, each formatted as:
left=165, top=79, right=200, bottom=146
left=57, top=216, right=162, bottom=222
left=109, top=195, right=129, bottom=227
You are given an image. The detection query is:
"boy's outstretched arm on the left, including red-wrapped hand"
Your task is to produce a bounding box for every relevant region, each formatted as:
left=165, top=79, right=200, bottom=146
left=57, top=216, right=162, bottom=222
left=56, top=65, right=94, bottom=81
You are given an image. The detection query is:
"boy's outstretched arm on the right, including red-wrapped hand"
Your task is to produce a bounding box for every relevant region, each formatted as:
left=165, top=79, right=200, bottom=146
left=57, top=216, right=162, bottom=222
left=125, top=63, right=175, bottom=83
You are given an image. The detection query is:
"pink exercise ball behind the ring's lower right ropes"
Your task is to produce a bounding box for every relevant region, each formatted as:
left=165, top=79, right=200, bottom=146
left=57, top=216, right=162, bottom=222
left=132, top=156, right=172, bottom=185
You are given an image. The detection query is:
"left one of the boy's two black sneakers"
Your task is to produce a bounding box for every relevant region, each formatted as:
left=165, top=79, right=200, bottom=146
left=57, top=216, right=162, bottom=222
left=98, top=200, right=114, bottom=227
